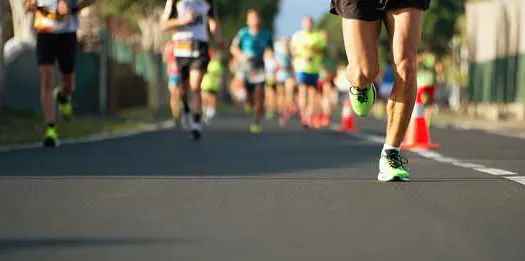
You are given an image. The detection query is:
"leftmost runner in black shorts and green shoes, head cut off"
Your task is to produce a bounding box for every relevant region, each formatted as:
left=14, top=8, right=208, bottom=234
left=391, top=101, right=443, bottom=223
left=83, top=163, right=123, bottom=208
left=26, top=0, right=95, bottom=147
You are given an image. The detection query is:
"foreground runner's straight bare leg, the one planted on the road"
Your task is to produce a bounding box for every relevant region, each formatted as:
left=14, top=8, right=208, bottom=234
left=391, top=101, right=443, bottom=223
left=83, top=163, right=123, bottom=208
left=385, top=8, right=422, bottom=147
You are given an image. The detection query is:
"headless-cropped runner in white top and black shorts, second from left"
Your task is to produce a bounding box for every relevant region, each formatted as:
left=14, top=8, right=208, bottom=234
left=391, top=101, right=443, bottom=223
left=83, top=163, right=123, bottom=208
left=163, top=0, right=222, bottom=140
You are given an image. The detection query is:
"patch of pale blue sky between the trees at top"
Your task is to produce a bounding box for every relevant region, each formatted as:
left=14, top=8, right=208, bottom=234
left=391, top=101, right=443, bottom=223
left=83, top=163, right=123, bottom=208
left=276, top=0, right=330, bottom=36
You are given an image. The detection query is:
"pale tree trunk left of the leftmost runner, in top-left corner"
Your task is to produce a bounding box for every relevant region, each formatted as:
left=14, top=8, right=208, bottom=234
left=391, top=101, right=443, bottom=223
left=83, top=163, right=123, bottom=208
left=9, top=0, right=35, bottom=42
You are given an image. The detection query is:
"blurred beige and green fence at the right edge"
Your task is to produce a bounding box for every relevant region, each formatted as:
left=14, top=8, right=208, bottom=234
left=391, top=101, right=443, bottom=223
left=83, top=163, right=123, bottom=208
left=466, top=0, right=525, bottom=105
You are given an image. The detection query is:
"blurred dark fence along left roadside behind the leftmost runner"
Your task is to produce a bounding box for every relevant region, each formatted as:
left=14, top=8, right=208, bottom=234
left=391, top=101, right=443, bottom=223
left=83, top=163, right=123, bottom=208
left=3, top=12, right=167, bottom=113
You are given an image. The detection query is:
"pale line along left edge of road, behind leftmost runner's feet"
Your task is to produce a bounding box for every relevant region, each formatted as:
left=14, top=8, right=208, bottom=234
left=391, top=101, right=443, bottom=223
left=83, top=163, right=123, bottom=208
left=0, top=120, right=175, bottom=153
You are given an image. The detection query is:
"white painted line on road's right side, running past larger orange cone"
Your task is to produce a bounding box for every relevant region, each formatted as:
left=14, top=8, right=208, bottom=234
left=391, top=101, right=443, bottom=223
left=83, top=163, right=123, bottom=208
left=351, top=133, right=525, bottom=185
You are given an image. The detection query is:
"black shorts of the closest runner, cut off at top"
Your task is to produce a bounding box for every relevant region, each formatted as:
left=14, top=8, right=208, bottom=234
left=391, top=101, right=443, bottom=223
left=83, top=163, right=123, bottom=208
left=330, top=0, right=430, bottom=21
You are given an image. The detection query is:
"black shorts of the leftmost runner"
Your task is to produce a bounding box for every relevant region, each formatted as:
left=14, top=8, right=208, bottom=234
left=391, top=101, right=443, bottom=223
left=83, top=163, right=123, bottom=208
left=36, top=33, right=77, bottom=74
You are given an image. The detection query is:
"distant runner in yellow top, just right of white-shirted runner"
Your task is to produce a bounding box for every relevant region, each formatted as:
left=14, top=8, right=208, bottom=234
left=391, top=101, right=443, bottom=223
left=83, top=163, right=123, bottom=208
left=202, top=51, right=224, bottom=124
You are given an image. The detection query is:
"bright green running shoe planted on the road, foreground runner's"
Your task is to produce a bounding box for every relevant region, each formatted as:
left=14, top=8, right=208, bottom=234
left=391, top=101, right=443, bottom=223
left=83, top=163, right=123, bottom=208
left=377, top=150, right=410, bottom=182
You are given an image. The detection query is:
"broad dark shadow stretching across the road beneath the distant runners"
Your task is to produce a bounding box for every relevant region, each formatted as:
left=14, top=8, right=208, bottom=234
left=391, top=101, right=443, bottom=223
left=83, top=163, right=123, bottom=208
left=0, top=118, right=380, bottom=177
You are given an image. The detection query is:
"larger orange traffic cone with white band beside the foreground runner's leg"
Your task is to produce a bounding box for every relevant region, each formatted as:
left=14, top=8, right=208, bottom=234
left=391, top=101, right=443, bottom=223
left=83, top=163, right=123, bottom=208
left=401, top=99, right=439, bottom=149
